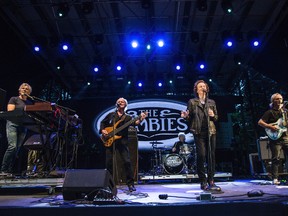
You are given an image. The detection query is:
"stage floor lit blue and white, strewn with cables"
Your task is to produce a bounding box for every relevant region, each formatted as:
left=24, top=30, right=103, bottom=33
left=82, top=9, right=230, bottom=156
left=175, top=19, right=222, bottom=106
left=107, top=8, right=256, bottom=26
left=0, top=175, right=288, bottom=216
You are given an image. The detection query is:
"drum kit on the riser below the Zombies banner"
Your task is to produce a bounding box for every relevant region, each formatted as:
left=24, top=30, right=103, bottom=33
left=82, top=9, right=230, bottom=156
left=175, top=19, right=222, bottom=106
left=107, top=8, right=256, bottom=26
left=150, top=141, right=196, bottom=175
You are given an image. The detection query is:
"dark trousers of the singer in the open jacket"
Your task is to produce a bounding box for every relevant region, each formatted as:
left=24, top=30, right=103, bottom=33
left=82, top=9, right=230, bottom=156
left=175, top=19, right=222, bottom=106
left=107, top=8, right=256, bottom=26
left=194, top=132, right=216, bottom=183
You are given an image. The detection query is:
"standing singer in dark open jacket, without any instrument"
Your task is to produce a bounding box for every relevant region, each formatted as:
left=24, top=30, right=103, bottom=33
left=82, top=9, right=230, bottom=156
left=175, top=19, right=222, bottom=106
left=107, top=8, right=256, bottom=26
left=181, top=80, right=221, bottom=191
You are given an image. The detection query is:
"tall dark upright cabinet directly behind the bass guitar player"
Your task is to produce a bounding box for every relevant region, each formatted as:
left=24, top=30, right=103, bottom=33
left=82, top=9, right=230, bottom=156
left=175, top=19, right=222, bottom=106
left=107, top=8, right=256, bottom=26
left=114, top=127, right=138, bottom=184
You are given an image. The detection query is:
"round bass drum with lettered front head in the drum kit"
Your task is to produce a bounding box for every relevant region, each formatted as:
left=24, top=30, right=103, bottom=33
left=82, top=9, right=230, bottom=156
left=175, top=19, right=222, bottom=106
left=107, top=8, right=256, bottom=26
left=164, top=154, right=184, bottom=174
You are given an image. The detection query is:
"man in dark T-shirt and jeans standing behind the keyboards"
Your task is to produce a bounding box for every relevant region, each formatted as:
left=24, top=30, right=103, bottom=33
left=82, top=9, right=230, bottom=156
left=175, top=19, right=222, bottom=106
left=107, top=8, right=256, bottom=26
left=1, top=83, right=33, bottom=176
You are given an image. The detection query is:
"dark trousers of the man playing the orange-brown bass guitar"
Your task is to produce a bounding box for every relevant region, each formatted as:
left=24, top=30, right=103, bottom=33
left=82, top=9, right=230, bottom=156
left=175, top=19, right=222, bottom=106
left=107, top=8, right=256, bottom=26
left=106, top=143, right=134, bottom=185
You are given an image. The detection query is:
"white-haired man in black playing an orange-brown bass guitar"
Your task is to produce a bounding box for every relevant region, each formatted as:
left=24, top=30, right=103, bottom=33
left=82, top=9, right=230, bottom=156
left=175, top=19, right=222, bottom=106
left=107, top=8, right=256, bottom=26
left=100, top=97, right=146, bottom=192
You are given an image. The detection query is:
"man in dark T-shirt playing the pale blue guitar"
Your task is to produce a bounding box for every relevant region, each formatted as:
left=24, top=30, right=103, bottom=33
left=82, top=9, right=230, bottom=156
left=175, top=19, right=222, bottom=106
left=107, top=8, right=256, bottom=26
left=258, top=93, right=288, bottom=185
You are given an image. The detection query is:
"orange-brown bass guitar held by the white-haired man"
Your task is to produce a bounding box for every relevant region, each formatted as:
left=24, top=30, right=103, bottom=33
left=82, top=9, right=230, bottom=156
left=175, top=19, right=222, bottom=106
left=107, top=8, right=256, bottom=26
left=101, top=114, right=141, bottom=147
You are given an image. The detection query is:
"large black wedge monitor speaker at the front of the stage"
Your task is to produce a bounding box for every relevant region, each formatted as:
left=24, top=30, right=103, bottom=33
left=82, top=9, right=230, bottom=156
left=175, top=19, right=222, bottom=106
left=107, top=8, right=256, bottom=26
left=62, top=169, right=117, bottom=200
